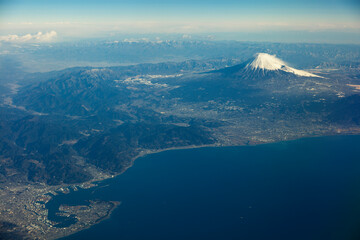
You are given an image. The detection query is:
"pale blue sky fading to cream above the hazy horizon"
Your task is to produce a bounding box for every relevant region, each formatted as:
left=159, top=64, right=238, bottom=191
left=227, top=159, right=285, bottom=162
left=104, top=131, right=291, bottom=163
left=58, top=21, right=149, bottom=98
left=0, top=0, right=360, bottom=43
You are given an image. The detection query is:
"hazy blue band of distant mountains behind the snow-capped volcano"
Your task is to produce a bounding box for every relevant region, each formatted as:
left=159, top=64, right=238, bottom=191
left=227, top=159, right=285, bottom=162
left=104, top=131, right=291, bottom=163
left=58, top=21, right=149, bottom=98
left=0, top=39, right=360, bottom=71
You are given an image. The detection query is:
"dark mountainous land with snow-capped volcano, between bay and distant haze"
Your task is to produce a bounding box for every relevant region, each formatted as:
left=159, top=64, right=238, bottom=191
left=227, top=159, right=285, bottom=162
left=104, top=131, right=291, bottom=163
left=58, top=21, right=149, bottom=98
left=0, top=53, right=360, bottom=185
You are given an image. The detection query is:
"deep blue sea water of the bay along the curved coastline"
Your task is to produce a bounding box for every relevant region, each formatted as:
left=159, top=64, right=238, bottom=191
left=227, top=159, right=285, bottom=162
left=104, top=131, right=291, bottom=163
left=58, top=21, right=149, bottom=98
left=53, top=136, right=360, bottom=240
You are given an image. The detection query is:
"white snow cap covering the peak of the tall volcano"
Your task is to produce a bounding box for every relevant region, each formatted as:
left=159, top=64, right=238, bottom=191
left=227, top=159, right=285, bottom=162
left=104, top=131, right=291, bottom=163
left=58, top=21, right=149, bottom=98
left=246, top=53, right=322, bottom=78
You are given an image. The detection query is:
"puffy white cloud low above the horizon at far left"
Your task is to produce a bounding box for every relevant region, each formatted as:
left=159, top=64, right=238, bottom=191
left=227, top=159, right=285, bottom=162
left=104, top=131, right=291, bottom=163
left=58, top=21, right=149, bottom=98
left=0, top=31, right=57, bottom=43
